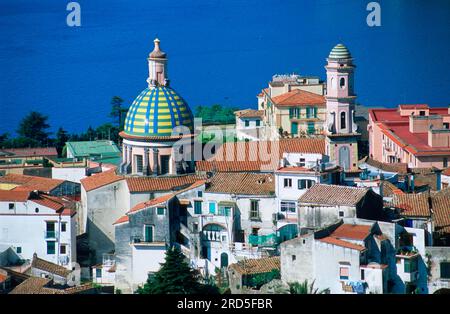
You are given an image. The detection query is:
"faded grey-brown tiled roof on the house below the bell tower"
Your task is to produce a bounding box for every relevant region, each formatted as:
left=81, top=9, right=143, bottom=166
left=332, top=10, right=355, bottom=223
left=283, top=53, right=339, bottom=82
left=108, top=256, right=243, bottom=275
left=299, top=184, right=370, bottom=206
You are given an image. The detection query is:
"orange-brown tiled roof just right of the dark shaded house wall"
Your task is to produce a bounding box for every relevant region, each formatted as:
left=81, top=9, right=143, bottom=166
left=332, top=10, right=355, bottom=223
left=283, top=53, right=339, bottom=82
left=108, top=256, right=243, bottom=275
left=392, top=193, right=431, bottom=217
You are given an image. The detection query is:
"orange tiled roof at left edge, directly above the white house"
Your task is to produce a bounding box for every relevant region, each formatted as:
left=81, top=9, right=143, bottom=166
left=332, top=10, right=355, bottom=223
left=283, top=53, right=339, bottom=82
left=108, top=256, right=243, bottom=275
left=0, top=173, right=64, bottom=192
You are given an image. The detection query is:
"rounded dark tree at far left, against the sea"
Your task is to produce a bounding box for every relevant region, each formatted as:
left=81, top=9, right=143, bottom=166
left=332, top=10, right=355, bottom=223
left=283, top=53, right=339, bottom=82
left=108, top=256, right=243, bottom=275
left=17, top=111, right=50, bottom=147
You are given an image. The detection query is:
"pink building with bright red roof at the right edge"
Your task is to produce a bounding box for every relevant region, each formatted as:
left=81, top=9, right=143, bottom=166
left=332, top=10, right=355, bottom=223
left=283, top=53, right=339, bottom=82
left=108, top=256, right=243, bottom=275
left=368, top=104, right=450, bottom=169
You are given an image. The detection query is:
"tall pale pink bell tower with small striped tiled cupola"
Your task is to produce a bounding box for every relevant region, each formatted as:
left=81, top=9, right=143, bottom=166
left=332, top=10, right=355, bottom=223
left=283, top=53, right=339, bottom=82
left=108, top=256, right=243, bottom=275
left=325, top=44, right=360, bottom=171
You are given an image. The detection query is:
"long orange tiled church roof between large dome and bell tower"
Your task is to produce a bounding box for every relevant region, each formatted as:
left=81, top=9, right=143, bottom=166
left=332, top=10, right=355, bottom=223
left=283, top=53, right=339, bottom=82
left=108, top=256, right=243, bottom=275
left=197, top=138, right=325, bottom=172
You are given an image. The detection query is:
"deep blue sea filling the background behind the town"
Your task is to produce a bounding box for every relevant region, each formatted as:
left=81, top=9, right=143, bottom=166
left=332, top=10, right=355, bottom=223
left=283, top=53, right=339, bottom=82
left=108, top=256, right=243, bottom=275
left=0, top=0, right=450, bottom=134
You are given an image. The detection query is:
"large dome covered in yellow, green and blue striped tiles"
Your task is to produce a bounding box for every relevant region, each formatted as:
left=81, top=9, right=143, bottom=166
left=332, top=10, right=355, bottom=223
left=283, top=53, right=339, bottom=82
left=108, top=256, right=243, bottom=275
left=124, top=86, right=194, bottom=137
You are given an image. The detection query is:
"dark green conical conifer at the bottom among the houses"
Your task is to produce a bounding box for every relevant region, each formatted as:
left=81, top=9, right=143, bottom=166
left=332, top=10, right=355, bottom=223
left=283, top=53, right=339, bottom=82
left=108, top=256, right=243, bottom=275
left=136, top=247, right=218, bottom=294
